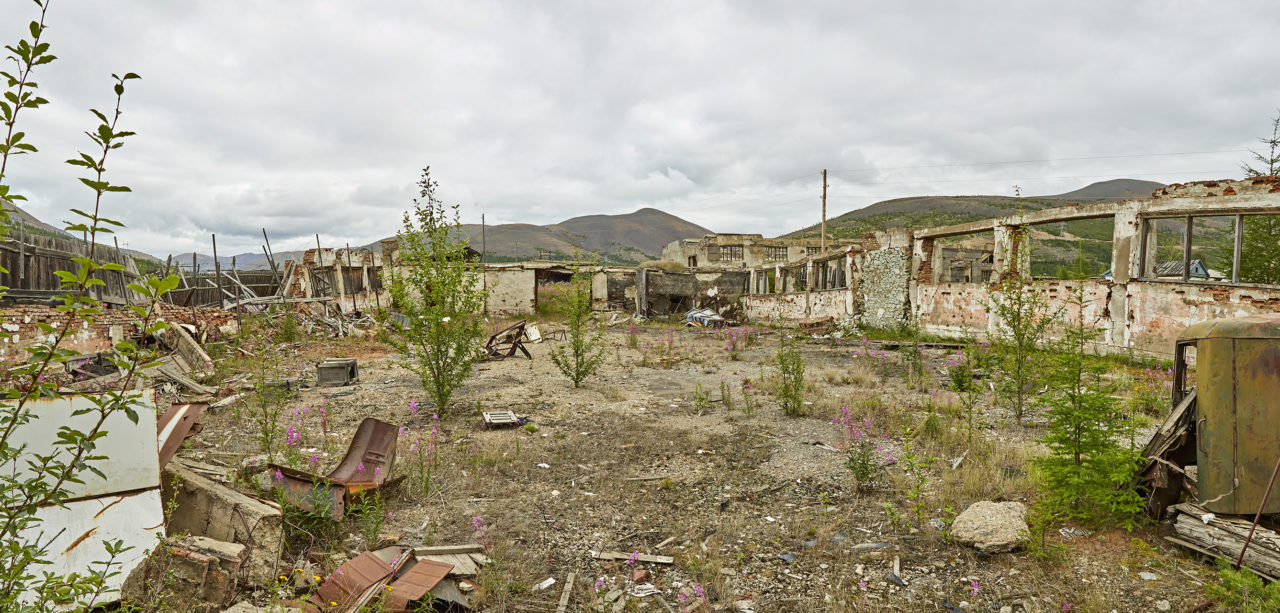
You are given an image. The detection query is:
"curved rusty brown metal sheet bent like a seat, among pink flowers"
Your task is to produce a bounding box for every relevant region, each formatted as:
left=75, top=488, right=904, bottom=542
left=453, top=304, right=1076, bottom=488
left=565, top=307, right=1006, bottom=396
left=269, top=417, right=399, bottom=521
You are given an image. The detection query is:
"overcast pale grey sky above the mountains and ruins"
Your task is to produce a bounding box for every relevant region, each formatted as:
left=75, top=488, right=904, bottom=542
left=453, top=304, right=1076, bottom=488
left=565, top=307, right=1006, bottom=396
left=0, top=0, right=1280, bottom=257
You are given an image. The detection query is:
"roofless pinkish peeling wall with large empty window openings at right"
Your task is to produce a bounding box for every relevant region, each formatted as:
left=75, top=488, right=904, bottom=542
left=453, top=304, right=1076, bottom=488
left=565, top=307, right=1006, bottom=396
left=911, top=178, right=1280, bottom=356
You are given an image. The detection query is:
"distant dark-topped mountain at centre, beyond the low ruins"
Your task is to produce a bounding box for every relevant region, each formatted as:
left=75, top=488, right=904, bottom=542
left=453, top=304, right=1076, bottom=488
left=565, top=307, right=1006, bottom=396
left=462, top=209, right=712, bottom=265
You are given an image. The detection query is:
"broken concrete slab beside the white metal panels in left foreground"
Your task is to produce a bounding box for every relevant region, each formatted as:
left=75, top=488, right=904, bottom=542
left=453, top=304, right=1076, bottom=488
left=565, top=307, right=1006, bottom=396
left=163, top=458, right=284, bottom=585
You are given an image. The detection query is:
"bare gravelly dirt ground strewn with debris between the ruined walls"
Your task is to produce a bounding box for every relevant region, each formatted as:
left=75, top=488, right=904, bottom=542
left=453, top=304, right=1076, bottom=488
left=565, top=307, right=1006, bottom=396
left=183, top=324, right=1215, bottom=612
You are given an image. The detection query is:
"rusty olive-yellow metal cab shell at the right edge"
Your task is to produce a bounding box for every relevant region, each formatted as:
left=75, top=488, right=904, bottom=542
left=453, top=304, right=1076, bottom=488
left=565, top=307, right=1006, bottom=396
left=1180, top=315, right=1280, bottom=514
